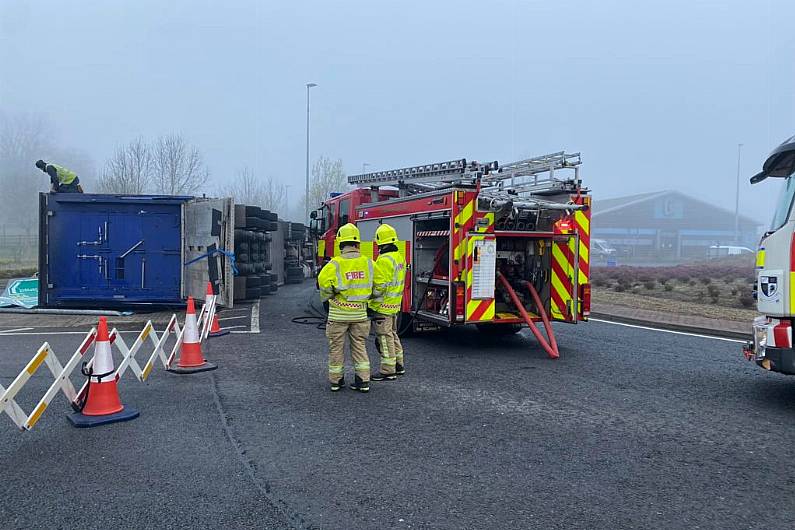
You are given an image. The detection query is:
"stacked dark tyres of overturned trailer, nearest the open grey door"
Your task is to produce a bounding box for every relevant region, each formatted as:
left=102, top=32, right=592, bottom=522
left=235, top=204, right=279, bottom=300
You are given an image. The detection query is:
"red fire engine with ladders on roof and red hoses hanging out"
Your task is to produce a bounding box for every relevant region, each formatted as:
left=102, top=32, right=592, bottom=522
left=312, top=152, right=591, bottom=357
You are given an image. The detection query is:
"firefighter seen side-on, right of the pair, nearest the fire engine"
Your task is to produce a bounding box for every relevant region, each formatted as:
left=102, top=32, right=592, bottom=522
left=369, top=224, right=406, bottom=381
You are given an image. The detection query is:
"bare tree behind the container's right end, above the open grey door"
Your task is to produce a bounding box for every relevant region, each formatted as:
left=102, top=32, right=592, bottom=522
left=152, top=134, right=209, bottom=195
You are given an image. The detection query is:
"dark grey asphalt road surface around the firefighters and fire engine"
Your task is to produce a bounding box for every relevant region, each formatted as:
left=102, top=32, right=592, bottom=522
left=0, top=284, right=795, bottom=529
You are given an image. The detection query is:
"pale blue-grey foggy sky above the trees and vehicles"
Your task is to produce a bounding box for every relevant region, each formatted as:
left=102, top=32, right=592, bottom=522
left=0, top=0, right=795, bottom=222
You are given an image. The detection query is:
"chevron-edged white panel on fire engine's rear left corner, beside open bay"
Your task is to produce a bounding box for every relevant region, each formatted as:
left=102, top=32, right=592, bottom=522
left=466, top=234, right=497, bottom=322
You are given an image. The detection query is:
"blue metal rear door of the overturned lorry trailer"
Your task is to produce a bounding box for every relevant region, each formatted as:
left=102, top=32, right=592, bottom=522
left=47, top=195, right=184, bottom=307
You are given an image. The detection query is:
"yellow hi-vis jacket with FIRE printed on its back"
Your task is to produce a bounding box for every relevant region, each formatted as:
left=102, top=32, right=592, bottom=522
left=317, top=247, right=373, bottom=322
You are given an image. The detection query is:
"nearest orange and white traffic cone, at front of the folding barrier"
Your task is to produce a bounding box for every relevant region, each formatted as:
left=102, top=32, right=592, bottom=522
left=69, top=317, right=139, bottom=427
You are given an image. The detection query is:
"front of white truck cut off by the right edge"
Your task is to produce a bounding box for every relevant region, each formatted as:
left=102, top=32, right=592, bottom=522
left=743, top=136, right=795, bottom=374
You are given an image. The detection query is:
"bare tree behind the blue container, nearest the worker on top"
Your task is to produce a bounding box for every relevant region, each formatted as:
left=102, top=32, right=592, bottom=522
left=98, top=137, right=154, bottom=195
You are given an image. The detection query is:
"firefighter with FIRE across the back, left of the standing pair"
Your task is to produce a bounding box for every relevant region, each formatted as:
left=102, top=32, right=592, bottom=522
left=318, top=223, right=373, bottom=392
